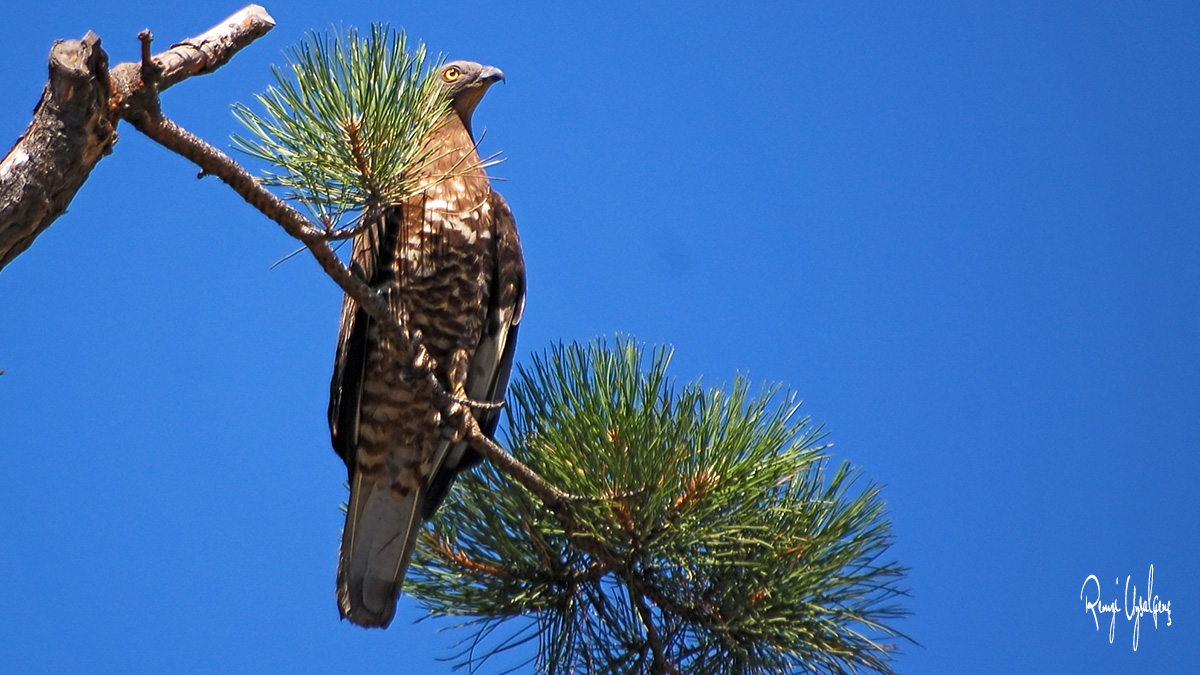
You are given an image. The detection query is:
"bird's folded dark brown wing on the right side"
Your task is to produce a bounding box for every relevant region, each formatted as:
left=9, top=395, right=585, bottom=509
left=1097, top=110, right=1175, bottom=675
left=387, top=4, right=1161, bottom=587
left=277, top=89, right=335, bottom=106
left=421, top=190, right=526, bottom=519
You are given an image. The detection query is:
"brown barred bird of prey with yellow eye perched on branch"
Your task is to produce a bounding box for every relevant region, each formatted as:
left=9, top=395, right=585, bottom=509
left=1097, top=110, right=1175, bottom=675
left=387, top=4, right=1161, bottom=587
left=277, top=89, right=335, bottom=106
left=329, top=61, right=524, bottom=627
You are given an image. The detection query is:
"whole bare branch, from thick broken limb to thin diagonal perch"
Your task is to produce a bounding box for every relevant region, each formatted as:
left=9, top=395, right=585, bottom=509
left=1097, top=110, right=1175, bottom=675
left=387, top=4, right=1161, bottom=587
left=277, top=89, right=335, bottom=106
left=0, top=5, right=574, bottom=526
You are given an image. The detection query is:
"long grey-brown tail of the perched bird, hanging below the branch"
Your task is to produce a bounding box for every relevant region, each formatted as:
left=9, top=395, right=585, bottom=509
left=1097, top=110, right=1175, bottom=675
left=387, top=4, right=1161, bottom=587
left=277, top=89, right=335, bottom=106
left=337, top=472, right=422, bottom=628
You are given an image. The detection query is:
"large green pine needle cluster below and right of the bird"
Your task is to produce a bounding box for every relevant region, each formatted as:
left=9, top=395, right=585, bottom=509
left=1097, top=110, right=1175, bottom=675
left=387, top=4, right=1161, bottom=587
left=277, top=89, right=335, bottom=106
left=406, top=339, right=907, bottom=675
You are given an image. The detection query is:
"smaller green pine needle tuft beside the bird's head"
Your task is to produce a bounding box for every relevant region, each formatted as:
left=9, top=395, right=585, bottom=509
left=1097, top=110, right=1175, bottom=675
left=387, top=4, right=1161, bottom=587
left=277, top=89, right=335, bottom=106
left=233, top=24, right=448, bottom=228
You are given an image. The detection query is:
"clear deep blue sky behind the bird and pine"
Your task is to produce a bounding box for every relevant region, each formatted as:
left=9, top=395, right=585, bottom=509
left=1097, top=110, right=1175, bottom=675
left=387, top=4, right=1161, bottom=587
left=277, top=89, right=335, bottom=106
left=0, top=0, right=1200, bottom=673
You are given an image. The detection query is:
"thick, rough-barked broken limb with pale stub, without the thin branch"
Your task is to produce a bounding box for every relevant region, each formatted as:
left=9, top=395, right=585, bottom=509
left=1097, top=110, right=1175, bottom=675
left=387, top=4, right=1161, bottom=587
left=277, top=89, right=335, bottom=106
left=0, top=5, right=275, bottom=270
